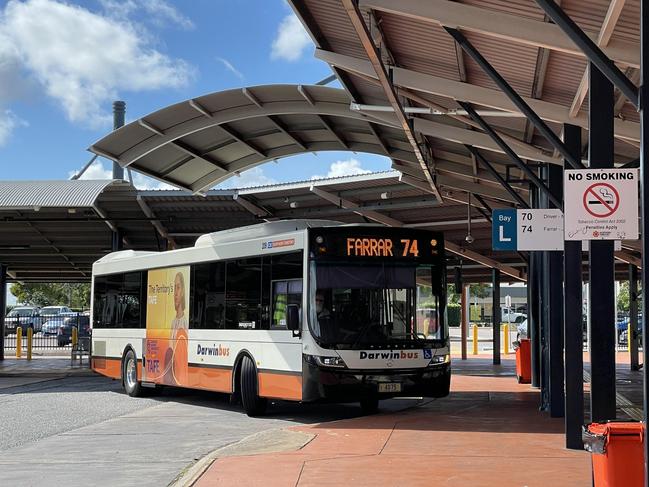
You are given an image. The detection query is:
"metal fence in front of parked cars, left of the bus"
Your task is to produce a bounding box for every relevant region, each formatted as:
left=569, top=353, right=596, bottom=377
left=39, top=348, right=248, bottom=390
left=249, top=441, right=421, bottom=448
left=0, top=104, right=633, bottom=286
left=4, top=311, right=90, bottom=354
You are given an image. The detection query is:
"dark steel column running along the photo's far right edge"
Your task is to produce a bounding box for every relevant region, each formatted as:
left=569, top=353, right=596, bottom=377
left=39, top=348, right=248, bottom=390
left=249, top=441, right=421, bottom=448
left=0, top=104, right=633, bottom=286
left=640, top=0, right=649, bottom=476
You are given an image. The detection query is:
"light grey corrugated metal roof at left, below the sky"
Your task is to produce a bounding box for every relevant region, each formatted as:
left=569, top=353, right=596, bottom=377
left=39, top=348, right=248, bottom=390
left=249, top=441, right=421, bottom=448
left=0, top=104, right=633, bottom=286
left=0, top=179, right=125, bottom=210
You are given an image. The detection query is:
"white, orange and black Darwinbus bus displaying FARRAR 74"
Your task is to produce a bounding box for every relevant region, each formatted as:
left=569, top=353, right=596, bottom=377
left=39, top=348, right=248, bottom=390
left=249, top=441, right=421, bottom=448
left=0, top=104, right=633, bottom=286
left=91, top=220, right=451, bottom=416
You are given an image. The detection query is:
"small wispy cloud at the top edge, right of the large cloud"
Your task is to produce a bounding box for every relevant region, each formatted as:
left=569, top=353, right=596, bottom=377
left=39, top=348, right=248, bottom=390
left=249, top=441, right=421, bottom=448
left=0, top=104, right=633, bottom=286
left=99, top=0, right=194, bottom=30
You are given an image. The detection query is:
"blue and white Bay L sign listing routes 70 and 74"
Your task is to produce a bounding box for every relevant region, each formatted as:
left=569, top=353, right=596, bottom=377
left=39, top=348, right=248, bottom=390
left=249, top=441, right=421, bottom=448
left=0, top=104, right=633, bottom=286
left=492, top=209, right=563, bottom=250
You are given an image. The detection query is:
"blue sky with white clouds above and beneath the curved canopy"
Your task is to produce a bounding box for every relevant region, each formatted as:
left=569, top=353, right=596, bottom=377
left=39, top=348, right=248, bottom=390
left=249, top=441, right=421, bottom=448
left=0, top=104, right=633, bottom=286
left=0, top=0, right=389, bottom=187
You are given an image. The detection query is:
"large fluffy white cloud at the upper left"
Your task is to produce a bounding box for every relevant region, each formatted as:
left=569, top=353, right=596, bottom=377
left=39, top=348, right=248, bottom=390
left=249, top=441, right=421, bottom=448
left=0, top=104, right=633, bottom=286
left=0, top=0, right=192, bottom=128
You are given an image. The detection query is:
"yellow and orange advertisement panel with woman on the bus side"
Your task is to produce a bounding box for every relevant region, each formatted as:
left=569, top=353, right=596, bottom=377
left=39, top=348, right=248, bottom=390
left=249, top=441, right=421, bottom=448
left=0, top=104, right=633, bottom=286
left=143, top=266, right=190, bottom=385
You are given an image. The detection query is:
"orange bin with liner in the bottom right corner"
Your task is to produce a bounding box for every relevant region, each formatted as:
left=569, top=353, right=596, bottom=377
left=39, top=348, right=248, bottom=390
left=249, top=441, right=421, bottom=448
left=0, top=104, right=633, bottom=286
left=583, top=422, right=644, bottom=487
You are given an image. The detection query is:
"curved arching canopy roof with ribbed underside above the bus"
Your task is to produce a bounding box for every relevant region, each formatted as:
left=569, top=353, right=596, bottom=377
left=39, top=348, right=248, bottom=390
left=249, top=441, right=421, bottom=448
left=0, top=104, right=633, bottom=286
left=90, top=85, right=413, bottom=193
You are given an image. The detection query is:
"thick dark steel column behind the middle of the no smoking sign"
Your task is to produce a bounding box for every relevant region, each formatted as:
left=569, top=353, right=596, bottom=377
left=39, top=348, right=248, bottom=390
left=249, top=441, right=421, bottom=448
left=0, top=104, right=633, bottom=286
left=588, top=63, right=615, bottom=422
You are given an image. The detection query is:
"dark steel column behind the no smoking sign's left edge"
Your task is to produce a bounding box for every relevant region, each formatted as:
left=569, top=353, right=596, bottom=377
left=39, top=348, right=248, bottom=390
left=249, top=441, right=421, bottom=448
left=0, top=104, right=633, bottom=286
left=563, top=124, right=584, bottom=450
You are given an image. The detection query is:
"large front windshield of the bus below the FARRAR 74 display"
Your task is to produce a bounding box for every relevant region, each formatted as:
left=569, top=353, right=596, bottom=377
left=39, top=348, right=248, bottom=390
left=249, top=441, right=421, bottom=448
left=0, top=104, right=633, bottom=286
left=309, top=262, right=446, bottom=349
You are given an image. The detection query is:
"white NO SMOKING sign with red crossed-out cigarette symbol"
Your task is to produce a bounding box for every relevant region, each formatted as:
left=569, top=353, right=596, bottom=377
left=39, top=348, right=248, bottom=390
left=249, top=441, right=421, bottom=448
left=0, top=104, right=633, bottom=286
left=564, top=169, right=638, bottom=240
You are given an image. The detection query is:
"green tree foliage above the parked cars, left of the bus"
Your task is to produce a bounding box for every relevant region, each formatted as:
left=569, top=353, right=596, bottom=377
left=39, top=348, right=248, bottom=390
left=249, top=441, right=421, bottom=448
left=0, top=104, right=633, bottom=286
left=11, top=282, right=90, bottom=308
